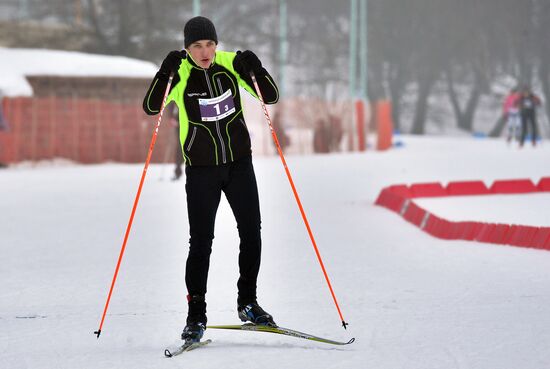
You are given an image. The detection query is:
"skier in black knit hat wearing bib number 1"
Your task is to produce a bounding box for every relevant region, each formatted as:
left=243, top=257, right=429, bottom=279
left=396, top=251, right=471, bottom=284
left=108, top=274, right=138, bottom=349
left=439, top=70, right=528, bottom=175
left=143, top=16, right=279, bottom=342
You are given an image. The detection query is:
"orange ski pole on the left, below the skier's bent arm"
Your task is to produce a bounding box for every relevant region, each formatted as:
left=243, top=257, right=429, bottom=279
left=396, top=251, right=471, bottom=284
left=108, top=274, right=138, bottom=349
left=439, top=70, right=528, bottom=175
left=94, top=74, right=174, bottom=338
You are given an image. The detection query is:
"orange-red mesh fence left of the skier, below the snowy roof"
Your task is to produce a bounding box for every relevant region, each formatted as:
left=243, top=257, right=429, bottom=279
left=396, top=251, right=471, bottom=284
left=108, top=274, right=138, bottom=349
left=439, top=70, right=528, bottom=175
left=0, top=97, right=170, bottom=163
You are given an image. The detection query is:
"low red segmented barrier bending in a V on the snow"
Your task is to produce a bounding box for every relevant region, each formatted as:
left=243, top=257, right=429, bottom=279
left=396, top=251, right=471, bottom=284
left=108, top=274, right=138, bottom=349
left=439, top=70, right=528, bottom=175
left=376, top=177, right=550, bottom=250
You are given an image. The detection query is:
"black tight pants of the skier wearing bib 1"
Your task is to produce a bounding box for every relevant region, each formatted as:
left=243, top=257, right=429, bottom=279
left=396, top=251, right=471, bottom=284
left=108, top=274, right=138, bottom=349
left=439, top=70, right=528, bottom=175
left=185, top=156, right=261, bottom=300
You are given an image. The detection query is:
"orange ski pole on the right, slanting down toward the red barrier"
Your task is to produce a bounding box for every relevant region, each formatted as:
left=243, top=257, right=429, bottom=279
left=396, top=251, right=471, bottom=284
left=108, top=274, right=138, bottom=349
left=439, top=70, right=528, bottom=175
left=250, top=72, right=348, bottom=329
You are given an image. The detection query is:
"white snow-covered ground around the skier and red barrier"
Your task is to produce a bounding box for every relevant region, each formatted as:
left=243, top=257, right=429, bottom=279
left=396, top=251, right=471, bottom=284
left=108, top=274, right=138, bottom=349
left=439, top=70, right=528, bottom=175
left=0, top=137, right=550, bottom=369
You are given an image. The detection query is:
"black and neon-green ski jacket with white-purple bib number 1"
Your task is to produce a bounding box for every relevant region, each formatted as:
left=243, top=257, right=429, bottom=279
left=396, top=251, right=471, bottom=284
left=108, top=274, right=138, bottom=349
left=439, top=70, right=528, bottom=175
left=143, top=51, right=279, bottom=165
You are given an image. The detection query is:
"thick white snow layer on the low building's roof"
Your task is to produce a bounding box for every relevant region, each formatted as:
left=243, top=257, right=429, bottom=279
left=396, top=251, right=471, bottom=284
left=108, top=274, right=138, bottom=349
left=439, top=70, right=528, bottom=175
left=0, top=47, right=158, bottom=97
